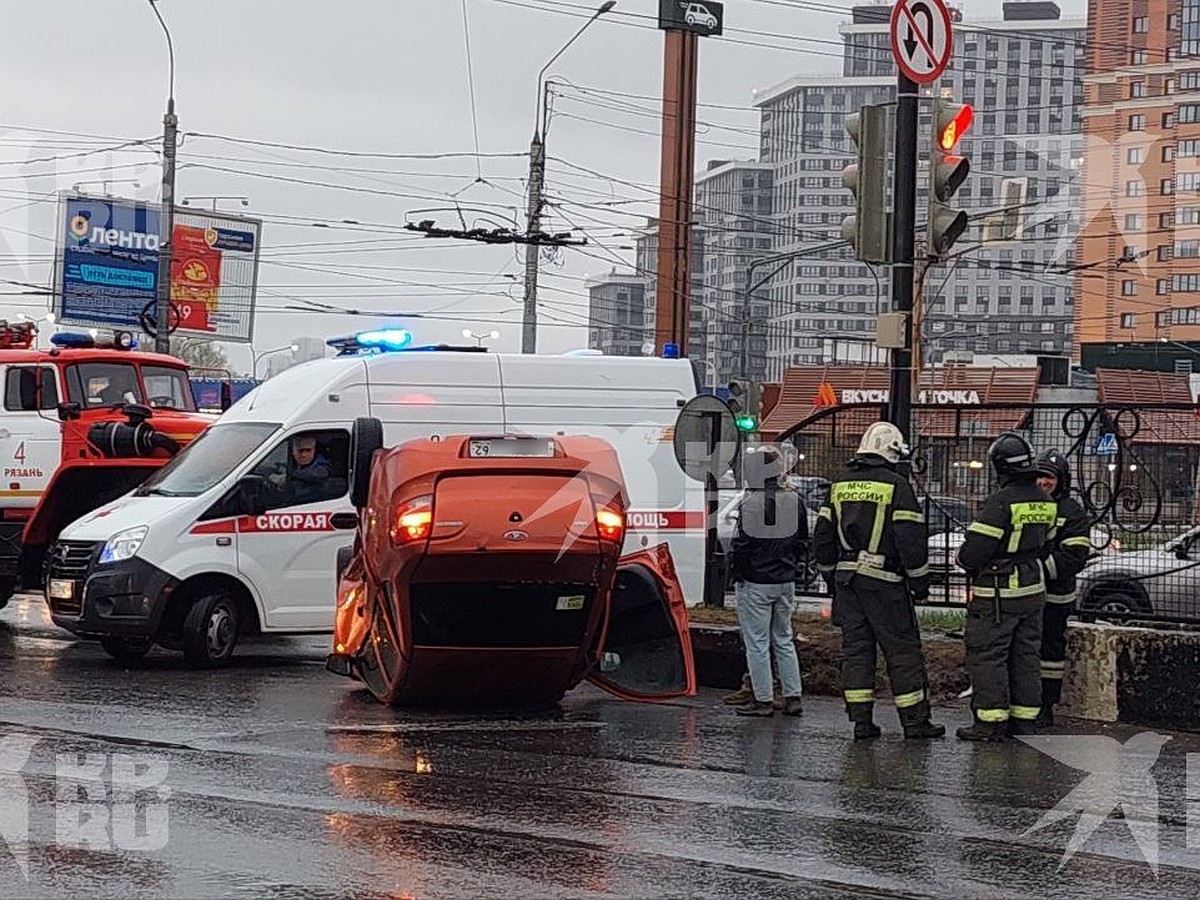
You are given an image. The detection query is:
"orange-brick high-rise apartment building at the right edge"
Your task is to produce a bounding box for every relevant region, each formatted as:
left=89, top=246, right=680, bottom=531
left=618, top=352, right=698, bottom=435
left=1076, top=0, right=1200, bottom=344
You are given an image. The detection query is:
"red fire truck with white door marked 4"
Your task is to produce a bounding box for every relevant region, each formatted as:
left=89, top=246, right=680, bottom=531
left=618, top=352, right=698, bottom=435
left=0, top=322, right=214, bottom=607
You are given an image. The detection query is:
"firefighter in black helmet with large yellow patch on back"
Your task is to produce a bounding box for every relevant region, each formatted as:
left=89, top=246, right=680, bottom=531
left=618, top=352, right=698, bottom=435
left=958, top=432, right=1058, bottom=740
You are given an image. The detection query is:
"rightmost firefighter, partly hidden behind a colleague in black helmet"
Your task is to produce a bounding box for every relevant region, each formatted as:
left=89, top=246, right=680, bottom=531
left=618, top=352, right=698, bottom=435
left=1037, top=450, right=1092, bottom=725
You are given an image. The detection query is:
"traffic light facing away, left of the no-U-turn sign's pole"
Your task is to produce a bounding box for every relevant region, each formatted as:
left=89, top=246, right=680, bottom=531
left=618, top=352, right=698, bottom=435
left=841, top=106, right=890, bottom=263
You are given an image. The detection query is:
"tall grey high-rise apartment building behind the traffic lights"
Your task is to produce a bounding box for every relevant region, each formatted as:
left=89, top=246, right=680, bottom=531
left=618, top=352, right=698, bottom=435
left=755, top=0, right=1084, bottom=379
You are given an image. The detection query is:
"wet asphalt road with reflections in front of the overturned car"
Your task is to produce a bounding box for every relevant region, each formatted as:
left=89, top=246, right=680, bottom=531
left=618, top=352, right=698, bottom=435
left=0, top=599, right=1200, bottom=900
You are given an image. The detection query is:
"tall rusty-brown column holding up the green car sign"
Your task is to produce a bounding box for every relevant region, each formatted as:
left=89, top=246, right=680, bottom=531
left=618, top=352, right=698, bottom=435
left=654, top=31, right=700, bottom=356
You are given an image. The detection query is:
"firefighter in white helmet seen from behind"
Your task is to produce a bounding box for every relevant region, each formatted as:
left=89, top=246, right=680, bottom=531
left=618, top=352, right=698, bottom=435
left=814, top=422, right=946, bottom=740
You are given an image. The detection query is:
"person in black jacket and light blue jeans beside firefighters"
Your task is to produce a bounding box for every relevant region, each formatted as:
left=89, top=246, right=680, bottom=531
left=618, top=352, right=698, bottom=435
left=732, top=448, right=809, bottom=716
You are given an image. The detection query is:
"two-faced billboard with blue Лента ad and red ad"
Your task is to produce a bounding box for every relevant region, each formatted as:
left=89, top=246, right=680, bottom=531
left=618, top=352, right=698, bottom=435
left=54, top=193, right=262, bottom=343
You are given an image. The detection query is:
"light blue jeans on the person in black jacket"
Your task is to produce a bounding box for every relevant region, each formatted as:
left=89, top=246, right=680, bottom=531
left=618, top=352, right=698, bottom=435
left=737, top=581, right=800, bottom=703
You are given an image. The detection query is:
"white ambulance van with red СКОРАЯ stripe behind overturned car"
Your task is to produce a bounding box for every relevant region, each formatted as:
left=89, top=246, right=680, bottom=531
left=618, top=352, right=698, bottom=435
left=46, top=331, right=704, bottom=666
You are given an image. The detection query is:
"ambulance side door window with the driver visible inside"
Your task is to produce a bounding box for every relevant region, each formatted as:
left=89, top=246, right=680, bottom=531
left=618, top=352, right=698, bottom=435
left=253, top=430, right=350, bottom=510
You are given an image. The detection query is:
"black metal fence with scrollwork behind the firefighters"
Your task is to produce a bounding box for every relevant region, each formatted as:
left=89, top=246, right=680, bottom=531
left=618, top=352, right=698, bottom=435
left=778, top=403, right=1200, bottom=624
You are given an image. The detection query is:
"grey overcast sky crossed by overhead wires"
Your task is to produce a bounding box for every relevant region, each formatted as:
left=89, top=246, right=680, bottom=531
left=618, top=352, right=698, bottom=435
left=0, top=0, right=1086, bottom=371
